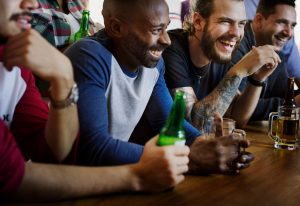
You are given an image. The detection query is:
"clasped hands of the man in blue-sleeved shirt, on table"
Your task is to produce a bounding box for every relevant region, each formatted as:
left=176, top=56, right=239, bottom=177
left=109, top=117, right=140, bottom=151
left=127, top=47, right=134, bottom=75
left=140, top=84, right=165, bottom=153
left=189, top=134, right=254, bottom=174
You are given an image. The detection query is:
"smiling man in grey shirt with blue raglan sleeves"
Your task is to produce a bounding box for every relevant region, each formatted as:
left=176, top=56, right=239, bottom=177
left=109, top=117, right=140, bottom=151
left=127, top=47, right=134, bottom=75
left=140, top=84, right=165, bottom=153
left=65, top=0, right=252, bottom=174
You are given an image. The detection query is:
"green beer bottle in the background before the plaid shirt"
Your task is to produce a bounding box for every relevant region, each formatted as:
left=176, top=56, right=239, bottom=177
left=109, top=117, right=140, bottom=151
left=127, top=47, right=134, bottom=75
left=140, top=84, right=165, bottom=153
left=70, top=10, right=90, bottom=43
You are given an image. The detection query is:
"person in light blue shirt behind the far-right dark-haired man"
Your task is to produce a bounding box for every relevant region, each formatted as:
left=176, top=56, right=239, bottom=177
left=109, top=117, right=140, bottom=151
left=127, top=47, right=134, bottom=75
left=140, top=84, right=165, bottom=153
left=244, top=0, right=300, bottom=79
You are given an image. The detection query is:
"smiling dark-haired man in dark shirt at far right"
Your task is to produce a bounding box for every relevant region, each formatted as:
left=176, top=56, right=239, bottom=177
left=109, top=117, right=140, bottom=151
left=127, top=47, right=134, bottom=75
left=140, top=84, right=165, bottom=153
left=231, top=0, right=300, bottom=121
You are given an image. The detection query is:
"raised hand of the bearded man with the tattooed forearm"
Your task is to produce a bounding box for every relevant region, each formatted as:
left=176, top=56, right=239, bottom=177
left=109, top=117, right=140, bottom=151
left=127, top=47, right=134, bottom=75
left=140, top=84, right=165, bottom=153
left=230, top=45, right=281, bottom=81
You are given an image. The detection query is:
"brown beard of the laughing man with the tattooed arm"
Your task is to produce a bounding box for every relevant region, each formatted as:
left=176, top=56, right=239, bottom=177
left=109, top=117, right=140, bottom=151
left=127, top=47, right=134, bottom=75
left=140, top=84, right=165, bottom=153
left=200, top=25, right=240, bottom=64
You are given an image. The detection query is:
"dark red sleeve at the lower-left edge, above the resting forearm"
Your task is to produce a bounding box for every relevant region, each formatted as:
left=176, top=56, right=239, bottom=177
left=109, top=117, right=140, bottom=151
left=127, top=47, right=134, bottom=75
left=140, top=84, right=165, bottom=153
left=0, top=120, right=25, bottom=195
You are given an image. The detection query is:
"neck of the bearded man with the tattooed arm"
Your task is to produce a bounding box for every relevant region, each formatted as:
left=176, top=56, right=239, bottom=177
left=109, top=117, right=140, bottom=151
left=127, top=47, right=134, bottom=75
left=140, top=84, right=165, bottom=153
left=188, top=35, right=210, bottom=68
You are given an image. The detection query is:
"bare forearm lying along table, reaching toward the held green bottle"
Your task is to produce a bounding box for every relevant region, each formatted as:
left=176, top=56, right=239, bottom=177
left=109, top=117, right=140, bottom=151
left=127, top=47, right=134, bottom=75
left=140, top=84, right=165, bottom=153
left=11, top=163, right=138, bottom=201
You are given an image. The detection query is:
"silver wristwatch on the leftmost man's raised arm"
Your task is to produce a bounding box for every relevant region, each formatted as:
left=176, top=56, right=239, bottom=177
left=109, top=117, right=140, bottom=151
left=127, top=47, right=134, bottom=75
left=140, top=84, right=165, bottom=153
left=49, top=83, right=79, bottom=109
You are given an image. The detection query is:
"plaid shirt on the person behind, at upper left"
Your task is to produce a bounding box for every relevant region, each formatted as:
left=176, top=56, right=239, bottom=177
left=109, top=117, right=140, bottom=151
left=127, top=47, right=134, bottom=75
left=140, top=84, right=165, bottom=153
left=32, top=0, right=94, bottom=47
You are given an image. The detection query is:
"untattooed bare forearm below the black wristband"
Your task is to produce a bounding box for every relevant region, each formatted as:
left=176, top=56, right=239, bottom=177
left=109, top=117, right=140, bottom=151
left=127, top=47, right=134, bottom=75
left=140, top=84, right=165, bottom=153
left=230, top=84, right=262, bottom=128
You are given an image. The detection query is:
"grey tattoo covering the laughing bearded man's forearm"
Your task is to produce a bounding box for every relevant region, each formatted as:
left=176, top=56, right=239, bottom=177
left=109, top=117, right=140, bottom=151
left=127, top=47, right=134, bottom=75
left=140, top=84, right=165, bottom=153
left=190, top=75, right=242, bottom=128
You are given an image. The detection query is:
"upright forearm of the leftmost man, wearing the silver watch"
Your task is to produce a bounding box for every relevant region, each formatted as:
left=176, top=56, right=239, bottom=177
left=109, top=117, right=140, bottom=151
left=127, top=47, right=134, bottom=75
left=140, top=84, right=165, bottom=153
left=45, top=58, right=79, bottom=161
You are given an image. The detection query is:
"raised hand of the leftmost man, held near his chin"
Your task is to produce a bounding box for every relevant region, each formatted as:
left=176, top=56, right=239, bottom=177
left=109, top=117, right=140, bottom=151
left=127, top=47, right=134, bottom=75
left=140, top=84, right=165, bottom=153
left=3, top=29, right=74, bottom=101
